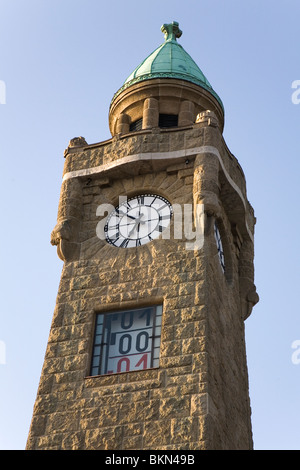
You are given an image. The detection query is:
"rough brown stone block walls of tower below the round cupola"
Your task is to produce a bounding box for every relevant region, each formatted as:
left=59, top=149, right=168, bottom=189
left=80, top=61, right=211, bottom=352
left=27, top=119, right=255, bottom=450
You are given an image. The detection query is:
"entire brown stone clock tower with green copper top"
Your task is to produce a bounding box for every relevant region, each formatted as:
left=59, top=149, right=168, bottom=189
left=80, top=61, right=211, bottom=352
left=27, top=22, right=258, bottom=450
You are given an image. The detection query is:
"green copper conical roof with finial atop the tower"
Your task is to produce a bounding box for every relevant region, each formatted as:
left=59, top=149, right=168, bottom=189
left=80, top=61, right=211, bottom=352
left=112, top=21, right=223, bottom=108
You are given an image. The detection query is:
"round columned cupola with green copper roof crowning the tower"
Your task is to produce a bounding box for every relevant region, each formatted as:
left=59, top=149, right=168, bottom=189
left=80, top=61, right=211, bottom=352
left=109, top=21, right=224, bottom=135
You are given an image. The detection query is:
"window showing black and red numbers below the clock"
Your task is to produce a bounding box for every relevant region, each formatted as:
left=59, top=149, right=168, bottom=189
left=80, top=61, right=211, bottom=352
left=91, top=305, right=162, bottom=375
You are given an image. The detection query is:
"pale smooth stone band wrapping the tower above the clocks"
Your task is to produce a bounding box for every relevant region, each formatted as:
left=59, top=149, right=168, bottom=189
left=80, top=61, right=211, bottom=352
left=63, top=145, right=254, bottom=242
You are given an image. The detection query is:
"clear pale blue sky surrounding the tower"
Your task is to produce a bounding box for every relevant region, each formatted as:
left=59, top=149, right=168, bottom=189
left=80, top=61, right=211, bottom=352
left=0, top=0, right=300, bottom=450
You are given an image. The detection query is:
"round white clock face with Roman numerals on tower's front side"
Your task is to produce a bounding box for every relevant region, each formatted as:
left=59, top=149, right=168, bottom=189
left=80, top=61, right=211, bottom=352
left=104, top=194, right=172, bottom=248
